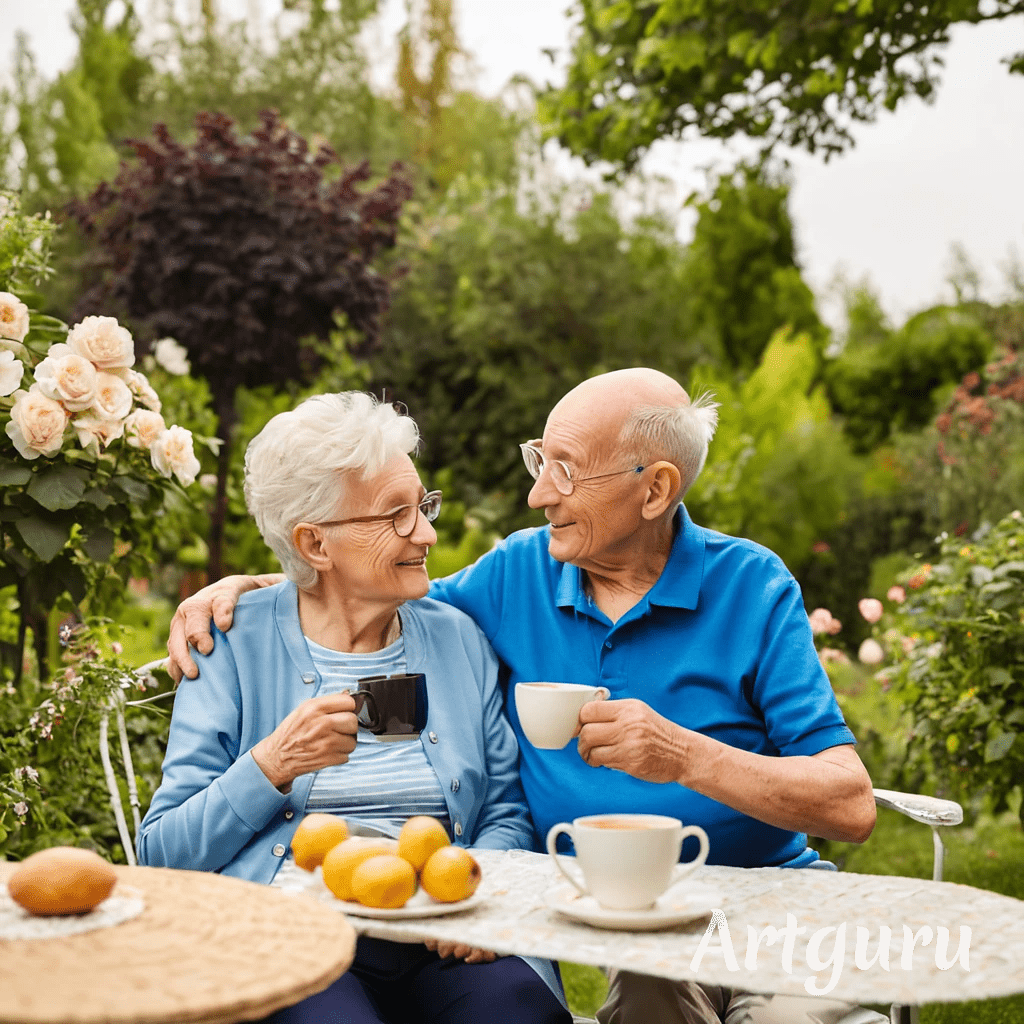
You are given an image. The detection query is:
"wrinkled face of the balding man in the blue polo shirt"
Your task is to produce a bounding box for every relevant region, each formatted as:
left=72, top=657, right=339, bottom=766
left=528, top=402, right=643, bottom=568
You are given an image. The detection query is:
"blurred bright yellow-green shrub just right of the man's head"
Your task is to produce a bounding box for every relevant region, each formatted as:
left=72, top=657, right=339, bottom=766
left=686, top=330, right=859, bottom=567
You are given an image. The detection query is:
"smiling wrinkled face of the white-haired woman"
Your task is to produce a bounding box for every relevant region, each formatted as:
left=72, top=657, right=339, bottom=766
left=324, top=455, right=437, bottom=602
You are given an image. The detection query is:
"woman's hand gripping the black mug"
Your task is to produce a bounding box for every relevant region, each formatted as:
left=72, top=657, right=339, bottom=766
left=252, top=693, right=359, bottom=793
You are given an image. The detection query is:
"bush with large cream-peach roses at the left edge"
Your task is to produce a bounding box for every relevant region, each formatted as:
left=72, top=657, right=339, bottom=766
left=0, top=192, right=201, bottom=685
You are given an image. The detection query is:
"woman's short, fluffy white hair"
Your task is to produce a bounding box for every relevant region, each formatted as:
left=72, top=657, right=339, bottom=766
left=245, top=391, right=420, bottom=587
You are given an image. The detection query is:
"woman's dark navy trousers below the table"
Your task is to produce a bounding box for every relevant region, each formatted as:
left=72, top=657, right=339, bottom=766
left=265, top=936, right=572, bottom=1024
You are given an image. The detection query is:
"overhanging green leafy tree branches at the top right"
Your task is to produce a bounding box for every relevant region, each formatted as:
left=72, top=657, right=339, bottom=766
left=541, top=0, right=1024, bottom=169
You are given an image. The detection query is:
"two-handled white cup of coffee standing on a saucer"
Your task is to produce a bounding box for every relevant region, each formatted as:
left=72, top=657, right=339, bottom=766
left=548, top=814, right=710, bottom=910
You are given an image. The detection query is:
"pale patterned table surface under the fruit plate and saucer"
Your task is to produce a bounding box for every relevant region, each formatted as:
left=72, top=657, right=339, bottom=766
left=276, top=850, right=1024, bottom=1005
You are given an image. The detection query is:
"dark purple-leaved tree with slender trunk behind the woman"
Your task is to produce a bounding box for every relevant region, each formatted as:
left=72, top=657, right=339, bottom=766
left=71, top=112, right=411, bottom=579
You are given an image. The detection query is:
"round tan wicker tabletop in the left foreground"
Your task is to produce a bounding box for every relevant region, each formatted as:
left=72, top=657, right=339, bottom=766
left=0, top=863, right=355, bottom=1024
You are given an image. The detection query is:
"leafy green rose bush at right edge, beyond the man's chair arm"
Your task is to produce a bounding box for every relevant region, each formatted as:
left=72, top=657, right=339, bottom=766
left=876, top=511, right=1024, bottom=812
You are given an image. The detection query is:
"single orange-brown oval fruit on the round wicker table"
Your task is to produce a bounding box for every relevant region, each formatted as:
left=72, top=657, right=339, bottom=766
left=7, top=846, right=118, bottom=916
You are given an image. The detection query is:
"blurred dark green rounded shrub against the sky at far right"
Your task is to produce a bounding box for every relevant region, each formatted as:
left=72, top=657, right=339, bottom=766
left=824, top=294, right=992, bottom=453
